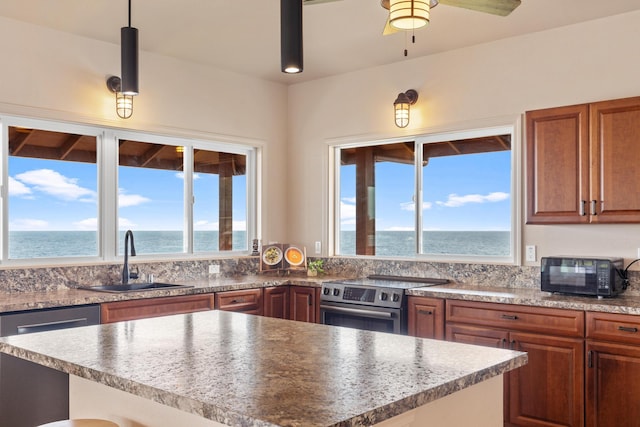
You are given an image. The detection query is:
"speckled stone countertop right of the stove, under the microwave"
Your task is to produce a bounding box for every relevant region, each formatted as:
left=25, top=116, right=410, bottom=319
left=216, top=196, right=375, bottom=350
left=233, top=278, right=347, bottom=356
left=407, top=284, right=640, bottom=315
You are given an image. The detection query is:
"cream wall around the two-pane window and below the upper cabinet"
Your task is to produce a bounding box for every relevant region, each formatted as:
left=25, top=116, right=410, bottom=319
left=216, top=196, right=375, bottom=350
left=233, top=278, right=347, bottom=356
left=288, top=12, right=640, bottom=264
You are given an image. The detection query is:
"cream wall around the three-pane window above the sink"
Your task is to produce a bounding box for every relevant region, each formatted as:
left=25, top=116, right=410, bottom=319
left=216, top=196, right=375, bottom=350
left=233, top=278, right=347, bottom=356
left=0, top=18, right=287, bottom=247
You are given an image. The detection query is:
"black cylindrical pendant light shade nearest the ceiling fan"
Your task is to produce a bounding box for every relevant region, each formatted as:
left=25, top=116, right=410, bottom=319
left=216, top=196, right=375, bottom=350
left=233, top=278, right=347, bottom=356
left=280, top=0, right=303, bottom=73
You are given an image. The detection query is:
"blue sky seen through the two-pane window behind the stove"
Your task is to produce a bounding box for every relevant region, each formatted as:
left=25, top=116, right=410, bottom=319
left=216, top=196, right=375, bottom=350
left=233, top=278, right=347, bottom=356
left=340, top=151, right=511, bottom=230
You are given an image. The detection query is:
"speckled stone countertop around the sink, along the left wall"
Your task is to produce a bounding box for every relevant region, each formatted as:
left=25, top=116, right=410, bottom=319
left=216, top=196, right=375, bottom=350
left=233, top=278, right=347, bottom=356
left=0, top=275, right=329, bottom=313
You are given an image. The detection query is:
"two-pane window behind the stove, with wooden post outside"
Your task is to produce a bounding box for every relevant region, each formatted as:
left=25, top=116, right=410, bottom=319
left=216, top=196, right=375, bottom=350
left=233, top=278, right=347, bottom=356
left=335, top=128, right=514, bottom=260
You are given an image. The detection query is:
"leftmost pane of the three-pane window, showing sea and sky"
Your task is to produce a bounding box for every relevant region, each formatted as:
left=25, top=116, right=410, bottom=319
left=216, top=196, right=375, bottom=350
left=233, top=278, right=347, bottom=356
left=7, top=126, right=99, bottom=259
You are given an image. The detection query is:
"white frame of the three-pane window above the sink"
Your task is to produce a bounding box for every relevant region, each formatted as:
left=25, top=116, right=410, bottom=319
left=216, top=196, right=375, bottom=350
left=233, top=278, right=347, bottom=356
left=0, top=115, right=261, bottom=266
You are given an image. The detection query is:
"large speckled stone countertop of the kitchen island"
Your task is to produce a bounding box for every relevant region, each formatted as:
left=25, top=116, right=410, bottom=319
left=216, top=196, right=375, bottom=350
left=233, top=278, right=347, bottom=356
left=0, top=310, right=527, bottom=426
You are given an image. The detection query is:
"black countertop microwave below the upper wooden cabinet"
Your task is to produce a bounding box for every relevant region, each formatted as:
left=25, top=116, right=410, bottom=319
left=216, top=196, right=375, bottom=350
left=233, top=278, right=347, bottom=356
left=540, top=256, right=627, bottom=297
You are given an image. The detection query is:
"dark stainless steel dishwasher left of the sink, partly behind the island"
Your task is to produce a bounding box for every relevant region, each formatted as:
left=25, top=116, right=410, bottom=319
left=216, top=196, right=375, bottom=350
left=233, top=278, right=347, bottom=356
left=0, top=304, right=100, bottom=427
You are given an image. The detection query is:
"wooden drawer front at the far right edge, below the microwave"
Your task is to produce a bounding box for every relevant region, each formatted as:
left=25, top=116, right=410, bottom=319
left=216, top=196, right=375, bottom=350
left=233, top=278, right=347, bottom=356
left=587, top=311, right=640, bottom=344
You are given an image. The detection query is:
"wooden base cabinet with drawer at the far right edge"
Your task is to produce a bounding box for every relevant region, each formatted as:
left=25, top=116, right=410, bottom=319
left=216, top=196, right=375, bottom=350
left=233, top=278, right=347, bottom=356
left=586, top=312, right=640, bottom=427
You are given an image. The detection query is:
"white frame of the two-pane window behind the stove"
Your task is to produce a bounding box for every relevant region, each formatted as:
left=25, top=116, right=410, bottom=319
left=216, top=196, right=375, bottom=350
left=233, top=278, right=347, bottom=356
left=328, top=123, right=522, bottom=265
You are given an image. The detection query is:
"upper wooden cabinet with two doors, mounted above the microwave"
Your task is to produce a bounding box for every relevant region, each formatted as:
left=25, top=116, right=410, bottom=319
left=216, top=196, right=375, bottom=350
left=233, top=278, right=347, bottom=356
left=526, top=97, right=640, bottom=224
